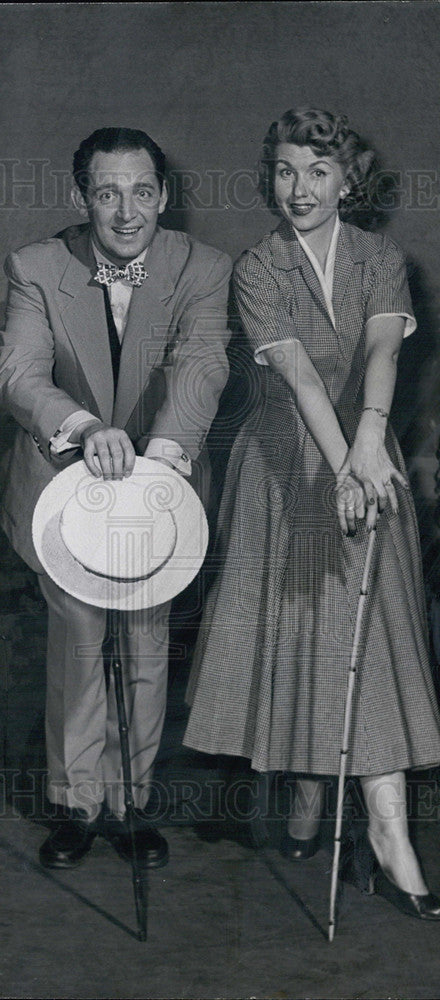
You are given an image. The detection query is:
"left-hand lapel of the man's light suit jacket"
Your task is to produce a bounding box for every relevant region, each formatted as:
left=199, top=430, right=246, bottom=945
left=59, top=227, right=113, bottom=423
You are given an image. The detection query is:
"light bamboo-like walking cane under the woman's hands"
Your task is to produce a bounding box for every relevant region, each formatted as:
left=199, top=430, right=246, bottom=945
left=328, top=527, right=376, bottom=941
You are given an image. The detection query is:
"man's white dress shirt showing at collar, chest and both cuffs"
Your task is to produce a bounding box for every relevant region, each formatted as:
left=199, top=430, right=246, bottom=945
left=50, top=242, right=191, bottom=476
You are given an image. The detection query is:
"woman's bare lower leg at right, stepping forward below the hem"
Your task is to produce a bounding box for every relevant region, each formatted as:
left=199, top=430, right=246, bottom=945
left=360, top=771, right=428, bottom=895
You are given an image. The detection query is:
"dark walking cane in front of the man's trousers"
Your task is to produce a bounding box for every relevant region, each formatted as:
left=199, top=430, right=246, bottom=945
left=110, top=608, right=147, bottom=941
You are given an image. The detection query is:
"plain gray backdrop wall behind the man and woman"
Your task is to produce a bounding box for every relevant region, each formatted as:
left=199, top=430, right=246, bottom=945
left=0, top=2, right=440, bottom=548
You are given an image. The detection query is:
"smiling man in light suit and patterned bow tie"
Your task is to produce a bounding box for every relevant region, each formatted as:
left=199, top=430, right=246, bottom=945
left=0, top=128, right=230, bottom=867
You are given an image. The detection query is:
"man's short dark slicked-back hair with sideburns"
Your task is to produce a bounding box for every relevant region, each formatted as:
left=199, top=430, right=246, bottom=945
left=73, top=126, right=165, bottom=198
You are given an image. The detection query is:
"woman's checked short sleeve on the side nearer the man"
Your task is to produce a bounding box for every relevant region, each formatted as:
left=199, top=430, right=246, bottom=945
left=234, top=250, right=299, bottom=365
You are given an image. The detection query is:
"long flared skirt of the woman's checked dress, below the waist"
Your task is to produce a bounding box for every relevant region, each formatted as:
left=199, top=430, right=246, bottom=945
left=184, top=404, right=440, bottom=775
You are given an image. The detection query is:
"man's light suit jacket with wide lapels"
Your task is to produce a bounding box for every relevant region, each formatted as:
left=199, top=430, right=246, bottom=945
left=0, top=225, right=231, bottom=572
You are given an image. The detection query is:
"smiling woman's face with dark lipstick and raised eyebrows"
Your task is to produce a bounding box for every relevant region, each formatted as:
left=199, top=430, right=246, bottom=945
left=274, top=142, right=349, bottom=233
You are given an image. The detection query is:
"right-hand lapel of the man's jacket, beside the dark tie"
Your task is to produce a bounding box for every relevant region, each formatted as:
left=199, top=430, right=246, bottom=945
left=113, top=228, right=180, bottom=427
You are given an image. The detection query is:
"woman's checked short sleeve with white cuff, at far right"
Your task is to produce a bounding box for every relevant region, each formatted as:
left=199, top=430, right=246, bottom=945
left=366, top=240, right=417, bottom=337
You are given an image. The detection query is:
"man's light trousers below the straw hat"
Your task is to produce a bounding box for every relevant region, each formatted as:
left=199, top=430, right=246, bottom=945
left=39, top=575, right=170, bottom=819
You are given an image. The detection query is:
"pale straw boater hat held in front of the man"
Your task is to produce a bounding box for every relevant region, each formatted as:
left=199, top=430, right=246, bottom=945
left=32, top=458, right=208, bottom=611
